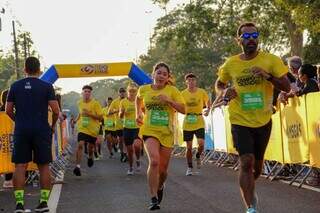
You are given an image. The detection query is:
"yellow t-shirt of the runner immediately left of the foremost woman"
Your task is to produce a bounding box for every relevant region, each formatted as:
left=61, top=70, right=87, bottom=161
left=120, top=98, right=139, bottom=129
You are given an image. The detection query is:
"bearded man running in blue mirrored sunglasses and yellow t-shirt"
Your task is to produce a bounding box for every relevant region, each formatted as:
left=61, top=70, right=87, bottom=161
left=215, top=22, right=290, bottom=213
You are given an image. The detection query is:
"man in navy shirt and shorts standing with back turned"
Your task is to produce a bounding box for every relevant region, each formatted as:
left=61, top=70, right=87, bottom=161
left=5, top=57, right=60, bottom=212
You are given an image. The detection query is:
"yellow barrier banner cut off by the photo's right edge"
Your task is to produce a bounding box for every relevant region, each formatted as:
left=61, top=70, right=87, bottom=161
left=306, top=92, right=320, bottom=168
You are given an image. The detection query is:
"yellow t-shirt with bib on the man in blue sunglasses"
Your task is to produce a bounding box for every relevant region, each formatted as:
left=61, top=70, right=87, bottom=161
left=218, top=52, right=288, bottom=127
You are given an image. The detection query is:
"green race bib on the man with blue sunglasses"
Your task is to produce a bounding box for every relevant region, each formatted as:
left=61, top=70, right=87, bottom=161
left=240, top=92, right=264, bottom=110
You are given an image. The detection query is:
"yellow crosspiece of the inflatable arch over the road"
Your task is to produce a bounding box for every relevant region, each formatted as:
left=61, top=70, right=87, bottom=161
left=54, top=62, right=132, bottom=78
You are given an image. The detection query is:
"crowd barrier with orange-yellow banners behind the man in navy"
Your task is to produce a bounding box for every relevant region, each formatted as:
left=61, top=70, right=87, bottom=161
left=0, top=112, right=71, bottom=181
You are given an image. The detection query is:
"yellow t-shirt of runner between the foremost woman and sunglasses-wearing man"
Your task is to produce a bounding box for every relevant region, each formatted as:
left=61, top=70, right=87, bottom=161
left=181, top=88, right=209, bottom=131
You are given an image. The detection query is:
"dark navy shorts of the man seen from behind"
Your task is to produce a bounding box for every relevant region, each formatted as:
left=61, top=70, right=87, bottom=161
left=12, top=132, right=52, bottom=164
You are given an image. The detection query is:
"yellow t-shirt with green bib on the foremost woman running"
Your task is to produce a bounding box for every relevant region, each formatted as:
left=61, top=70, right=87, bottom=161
left=137, top=85, right=184, bottom=147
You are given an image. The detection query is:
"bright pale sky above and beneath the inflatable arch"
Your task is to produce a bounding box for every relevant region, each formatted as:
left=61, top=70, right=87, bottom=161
left=0, top=0, right=185, bottom=93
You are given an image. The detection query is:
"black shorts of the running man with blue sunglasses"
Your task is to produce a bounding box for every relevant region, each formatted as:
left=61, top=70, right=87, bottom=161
left=231, top=120, right=272, bottom=160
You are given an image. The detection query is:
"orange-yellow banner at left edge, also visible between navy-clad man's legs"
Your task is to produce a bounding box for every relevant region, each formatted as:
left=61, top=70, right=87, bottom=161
left=0, top=112, right=38, bottom=174
